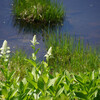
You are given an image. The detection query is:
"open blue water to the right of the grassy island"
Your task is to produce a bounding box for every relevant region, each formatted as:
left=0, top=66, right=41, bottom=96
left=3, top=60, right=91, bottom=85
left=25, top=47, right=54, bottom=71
left=62, top=0, right=100, bottom=46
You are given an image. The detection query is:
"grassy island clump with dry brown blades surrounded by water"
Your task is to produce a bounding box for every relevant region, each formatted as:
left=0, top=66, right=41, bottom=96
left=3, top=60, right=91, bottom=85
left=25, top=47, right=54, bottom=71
left=13, top=0, right=65, bottom=24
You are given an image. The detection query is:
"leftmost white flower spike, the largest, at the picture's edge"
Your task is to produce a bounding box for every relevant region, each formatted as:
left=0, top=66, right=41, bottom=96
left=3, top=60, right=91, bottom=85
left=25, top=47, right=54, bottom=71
left=0, top=40, right=10, bottom=61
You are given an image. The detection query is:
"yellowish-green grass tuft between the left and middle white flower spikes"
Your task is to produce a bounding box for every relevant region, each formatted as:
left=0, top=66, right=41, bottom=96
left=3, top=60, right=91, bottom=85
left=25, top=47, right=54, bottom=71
left=9, top=50, right=32, bottom=79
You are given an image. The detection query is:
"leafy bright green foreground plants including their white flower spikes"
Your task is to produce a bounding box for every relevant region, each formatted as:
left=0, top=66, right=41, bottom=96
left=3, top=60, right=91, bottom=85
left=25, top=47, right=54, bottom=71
left=0, top=35, right=100, bottom=100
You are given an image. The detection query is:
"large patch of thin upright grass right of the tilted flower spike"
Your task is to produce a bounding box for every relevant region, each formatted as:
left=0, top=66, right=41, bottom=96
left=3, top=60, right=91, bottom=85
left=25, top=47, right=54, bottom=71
left=45, top=33, right=100, bottom=73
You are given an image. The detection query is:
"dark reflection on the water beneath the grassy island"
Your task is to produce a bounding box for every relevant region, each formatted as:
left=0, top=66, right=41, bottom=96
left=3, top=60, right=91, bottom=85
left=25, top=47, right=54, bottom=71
left=12, top=16, right=61, bottom=34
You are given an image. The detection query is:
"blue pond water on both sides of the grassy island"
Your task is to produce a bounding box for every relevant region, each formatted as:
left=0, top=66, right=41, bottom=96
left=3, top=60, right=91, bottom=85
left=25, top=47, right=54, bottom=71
left=0, top=0, right=100, bottom=58
